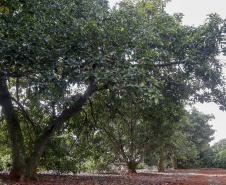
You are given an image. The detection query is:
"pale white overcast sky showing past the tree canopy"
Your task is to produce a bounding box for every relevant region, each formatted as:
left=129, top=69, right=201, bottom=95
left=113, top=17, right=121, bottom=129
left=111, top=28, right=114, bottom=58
left=109, top=0, right=226, bottom=145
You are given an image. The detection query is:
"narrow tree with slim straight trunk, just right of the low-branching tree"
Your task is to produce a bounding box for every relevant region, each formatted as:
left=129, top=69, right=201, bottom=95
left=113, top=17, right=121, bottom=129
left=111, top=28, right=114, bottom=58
left=145, top=100, right=185, bottom=172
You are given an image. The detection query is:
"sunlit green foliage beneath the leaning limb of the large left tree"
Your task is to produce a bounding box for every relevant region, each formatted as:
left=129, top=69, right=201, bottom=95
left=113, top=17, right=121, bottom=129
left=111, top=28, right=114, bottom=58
left=40, top=108, right=113, bottom=173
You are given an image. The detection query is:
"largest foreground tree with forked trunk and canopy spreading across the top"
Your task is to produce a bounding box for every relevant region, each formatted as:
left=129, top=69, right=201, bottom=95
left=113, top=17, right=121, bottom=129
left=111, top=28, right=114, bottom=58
left=0, top=0, right=224, bottom=180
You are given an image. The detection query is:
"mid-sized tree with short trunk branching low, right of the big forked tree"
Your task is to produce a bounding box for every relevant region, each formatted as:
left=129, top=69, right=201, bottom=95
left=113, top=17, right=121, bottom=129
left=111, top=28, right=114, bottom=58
left=90, top=81, right=186, bottom=173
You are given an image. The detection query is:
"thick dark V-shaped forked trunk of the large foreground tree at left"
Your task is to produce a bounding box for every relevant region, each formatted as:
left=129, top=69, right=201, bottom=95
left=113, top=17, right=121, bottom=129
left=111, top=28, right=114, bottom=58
left=0, top=77, right=99, bottom=181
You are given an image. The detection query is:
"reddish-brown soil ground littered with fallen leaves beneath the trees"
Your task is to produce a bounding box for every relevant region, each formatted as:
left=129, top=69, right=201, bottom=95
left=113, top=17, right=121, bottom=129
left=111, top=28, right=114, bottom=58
left=0, top=168, right=226, bottom=185
